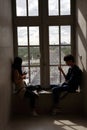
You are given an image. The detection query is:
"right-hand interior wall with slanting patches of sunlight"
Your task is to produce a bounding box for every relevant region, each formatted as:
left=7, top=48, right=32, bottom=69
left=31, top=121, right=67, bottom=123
left=76, top=0, right=87, bottom=115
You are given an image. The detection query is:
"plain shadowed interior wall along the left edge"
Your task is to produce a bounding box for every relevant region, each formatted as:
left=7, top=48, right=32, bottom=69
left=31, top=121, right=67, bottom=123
left=0, top=0, right=13, bottom=130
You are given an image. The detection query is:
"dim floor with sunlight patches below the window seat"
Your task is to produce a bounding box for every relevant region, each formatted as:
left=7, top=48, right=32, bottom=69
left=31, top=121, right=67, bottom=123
left=6, top=114, right=87, bottom=130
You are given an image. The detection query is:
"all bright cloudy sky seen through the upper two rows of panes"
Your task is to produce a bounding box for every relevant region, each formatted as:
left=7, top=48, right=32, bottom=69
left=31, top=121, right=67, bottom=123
left=16, top=0, right=70, bottom=45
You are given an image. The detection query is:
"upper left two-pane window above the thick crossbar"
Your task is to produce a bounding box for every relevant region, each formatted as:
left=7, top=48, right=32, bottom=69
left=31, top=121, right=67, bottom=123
left=16, top=0, right=39, bottom=16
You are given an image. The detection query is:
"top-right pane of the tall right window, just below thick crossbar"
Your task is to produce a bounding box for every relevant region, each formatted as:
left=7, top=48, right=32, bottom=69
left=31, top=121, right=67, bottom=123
left=61, top=26, right=71, bottom=45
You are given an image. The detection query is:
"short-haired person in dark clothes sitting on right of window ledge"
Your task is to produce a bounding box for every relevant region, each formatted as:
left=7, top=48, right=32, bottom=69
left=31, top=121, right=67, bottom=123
left=51, top=55, right=82, bottom=114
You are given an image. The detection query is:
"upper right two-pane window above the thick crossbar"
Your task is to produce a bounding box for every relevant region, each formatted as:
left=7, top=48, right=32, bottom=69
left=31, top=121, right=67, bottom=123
left=48, top=0, right=71, bottom=16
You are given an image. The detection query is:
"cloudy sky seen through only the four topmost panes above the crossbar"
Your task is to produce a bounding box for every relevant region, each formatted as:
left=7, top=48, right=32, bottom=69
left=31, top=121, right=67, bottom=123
left=16, top=0, right=70, bottom=16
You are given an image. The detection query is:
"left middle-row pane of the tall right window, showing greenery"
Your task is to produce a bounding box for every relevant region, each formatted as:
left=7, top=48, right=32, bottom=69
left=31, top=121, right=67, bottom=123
left=49, top=46, right=59, bottom=65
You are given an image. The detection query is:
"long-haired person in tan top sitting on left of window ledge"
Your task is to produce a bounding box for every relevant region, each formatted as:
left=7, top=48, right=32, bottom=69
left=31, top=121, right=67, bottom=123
left=12, top=57, right=38, bottom=116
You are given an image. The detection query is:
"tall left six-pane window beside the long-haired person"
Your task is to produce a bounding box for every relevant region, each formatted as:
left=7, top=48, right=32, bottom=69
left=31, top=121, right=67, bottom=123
left=17, top=26, right=40, bottom=84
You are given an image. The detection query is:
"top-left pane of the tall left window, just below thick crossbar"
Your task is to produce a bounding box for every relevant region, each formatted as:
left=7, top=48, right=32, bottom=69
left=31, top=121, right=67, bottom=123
left=17, top=27, right=28, bottom=46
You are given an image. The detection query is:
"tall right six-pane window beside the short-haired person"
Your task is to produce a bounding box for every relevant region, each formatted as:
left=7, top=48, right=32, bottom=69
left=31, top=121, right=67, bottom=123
left=49, top=26, right=71, bottom=84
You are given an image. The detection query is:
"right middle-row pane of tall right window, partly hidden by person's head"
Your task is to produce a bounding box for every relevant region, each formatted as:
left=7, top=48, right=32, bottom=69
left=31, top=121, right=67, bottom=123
left=61, top=46, right=71, bottom=64
